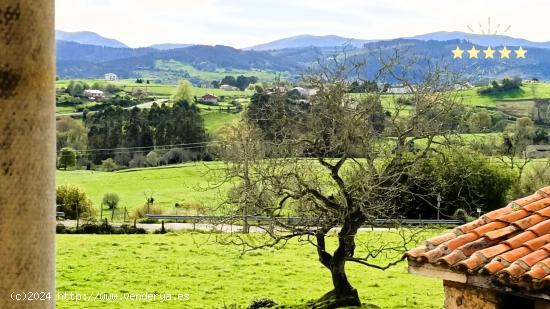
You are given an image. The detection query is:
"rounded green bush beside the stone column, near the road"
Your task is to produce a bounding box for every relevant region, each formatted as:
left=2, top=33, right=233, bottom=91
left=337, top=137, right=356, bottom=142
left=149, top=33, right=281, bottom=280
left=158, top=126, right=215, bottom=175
left=56, top=185, right=96, bottom=219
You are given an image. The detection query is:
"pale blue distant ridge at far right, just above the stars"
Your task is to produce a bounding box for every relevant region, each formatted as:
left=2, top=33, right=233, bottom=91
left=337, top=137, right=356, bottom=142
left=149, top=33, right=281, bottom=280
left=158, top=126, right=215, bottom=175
left=409, top=31, right=550, bottom=49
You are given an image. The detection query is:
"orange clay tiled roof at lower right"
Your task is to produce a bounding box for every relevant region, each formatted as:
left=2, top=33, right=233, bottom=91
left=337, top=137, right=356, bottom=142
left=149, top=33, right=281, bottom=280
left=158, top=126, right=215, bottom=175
left=405, top=187, right=550, bottom=290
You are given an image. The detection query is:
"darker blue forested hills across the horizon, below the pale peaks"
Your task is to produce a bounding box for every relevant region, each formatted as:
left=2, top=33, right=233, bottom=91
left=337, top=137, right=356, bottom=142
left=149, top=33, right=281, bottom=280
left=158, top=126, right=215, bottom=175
left=57, top=39, right=550, bottom=80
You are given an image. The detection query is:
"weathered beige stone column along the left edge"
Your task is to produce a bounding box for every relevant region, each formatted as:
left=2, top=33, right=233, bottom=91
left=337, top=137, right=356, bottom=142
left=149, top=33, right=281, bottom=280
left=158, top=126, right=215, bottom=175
left=0, top=0, right=55, bottom=308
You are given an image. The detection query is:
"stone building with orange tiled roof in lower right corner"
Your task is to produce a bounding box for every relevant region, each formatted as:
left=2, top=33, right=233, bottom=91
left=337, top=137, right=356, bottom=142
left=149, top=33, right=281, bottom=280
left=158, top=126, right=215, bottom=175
left=405, top=187, right=550, bottom=309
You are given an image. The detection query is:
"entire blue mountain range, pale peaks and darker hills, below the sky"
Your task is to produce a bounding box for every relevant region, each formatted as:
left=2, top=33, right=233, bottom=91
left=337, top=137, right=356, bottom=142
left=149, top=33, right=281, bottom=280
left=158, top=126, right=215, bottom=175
left=57, top=31, right=550, bottom=84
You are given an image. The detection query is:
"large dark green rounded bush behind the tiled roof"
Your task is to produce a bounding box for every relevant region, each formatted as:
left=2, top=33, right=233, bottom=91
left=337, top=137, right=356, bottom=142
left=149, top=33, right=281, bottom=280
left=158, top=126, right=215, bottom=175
left=397, top=149, right=516, bottom=219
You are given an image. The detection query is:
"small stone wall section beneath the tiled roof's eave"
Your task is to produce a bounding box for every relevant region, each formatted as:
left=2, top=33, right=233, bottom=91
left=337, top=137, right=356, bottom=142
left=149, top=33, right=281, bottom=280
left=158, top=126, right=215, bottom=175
left=443, top=281, right=501, bottom=309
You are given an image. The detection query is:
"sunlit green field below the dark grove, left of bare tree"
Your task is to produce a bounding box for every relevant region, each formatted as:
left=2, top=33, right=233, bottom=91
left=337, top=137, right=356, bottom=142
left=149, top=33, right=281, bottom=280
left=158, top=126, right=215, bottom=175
left=56, top=163, right=227, bottom=211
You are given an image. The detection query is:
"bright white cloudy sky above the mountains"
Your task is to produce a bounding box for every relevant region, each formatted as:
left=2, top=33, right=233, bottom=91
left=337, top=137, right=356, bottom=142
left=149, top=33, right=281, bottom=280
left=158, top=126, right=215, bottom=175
left=56, top=0, right=550, bottom=48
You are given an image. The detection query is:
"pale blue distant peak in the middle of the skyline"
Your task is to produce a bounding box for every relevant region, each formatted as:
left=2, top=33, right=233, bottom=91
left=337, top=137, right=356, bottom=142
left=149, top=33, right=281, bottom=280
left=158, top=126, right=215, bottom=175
left=246, top=34, right=372, bottom=51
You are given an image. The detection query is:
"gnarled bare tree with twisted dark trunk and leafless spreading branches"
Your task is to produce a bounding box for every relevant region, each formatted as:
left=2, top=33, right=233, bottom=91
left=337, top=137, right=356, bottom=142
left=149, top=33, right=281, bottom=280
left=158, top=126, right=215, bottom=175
left=209, top=54, right=468, bottom=308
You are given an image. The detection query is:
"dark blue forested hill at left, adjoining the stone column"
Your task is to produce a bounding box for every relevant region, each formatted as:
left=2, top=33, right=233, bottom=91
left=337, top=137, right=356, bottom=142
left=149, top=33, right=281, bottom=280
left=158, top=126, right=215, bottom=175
left=57, top=41, right=309, bottom=79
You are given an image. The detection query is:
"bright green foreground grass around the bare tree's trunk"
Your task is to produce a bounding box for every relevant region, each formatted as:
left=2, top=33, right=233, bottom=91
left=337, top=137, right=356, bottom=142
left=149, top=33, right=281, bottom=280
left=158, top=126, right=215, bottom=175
left=56, top=231, right=443, bottom=309
